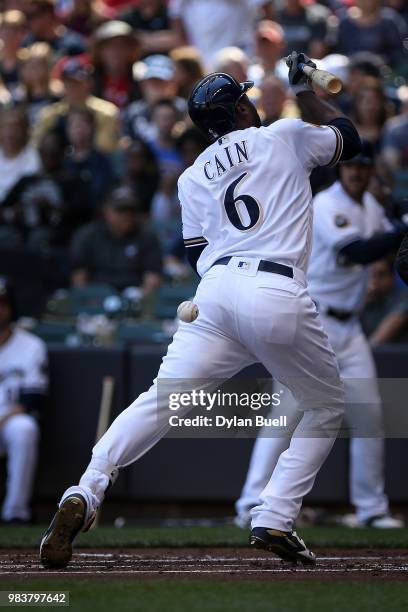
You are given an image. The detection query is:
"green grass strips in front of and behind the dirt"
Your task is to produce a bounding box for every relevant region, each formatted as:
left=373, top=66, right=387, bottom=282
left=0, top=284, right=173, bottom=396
left=0, top=527, right=408, bottom=612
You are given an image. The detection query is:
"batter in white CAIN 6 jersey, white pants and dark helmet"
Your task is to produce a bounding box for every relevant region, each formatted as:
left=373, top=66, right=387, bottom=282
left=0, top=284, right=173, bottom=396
left=40, top=53, right=360, bottom=567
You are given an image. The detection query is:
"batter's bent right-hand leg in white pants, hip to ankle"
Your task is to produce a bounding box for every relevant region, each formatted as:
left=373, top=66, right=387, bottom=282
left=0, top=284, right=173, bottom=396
left=241, top=280, right=344, bottom=560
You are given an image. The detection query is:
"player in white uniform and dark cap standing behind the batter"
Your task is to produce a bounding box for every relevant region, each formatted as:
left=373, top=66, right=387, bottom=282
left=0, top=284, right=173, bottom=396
left=236, top=143, right=403, bottom=528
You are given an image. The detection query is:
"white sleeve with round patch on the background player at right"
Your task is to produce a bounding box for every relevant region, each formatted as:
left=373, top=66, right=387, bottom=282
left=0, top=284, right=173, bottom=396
left=313, top=193, right=361, bottom=252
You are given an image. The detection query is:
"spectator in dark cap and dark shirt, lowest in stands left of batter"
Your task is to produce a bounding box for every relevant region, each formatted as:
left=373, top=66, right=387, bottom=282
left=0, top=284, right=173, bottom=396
left=71, top=187, right=162, bottom=296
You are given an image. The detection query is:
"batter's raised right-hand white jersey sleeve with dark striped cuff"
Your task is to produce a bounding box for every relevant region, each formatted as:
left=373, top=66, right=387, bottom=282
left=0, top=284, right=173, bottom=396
left=271, top=119, right=343, bottom=172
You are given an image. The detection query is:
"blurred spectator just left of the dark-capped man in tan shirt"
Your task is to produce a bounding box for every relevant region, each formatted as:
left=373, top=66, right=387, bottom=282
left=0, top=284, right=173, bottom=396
left=18, top=43, right=62, bottom=126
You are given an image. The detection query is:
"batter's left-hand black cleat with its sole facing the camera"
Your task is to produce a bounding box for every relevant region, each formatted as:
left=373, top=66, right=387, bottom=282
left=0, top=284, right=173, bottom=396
left=40, top=493, right=92, bottom=569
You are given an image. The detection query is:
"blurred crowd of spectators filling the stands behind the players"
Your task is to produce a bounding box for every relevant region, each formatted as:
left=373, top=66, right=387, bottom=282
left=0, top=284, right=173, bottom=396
left=0, top=0, right=408, bottom=519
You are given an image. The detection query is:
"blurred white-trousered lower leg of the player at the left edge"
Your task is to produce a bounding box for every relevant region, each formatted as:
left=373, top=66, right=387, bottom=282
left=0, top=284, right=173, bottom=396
left=1, top=414, right=39, bottom=521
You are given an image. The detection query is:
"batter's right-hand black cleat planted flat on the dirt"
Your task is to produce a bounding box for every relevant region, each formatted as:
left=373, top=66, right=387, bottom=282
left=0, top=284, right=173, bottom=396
left=249, top=527, right=316, bottom=565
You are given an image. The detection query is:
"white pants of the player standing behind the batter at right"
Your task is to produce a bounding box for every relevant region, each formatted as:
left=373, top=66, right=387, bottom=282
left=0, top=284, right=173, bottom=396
left=236, top=316, right=389, bottom=523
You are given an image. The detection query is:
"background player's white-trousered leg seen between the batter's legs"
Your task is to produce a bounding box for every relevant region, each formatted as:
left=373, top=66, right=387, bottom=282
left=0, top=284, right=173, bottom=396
left=235, top=381, right=301, bottom=527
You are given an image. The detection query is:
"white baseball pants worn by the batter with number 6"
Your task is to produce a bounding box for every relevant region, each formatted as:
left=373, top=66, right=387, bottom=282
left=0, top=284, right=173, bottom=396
left=71, top=257, right=344, bottom=531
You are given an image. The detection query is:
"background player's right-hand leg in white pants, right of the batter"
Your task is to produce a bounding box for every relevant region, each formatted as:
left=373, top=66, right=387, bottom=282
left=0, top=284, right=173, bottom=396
left=340, top=324, right=389, bottom=522
